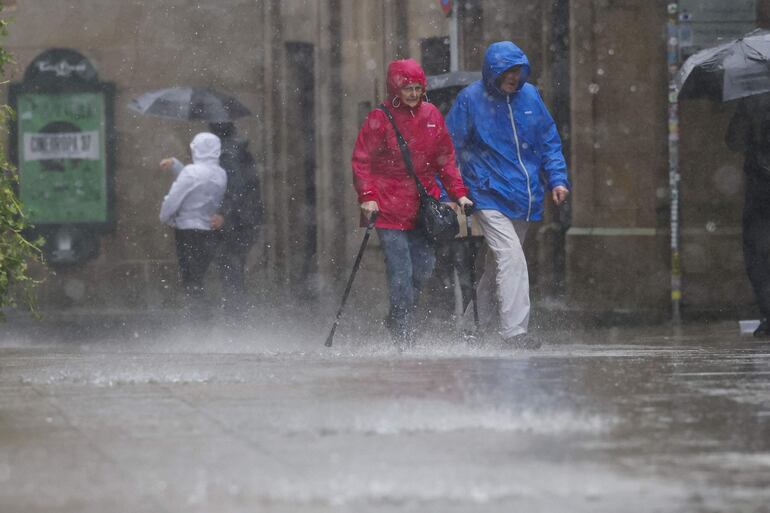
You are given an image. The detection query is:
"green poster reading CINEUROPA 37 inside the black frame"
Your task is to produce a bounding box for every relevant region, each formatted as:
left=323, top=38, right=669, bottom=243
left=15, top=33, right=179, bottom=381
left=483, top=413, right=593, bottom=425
left=16, top=92, right=108, bottom=224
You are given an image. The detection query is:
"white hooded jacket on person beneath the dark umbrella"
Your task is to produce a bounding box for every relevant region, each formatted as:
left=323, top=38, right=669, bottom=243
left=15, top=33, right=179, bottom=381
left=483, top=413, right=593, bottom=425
left=160, top=132, right=227, bottom=230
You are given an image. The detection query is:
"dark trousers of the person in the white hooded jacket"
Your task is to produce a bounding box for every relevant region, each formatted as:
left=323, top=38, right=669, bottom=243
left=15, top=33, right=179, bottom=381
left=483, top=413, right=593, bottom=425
left=174, top=230, right=219, bottom=299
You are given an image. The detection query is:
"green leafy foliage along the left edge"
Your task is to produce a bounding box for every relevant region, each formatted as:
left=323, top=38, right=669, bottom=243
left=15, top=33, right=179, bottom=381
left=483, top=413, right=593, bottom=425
left=0, top=5, right=42, bottom=319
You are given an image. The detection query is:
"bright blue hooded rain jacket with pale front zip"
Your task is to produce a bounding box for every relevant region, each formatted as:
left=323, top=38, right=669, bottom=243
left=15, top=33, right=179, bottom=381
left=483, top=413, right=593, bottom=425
left=447, top=41, right=570, bottom=221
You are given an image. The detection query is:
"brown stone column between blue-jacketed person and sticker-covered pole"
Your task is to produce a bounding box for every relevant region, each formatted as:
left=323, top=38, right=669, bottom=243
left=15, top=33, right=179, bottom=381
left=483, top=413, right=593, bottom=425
left=566, top=0, right=669, bottom=314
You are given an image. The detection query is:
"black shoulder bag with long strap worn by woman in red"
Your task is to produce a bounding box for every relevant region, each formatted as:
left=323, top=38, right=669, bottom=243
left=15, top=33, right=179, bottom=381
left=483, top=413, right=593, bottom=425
left=380, top=105, right=460, bottom=243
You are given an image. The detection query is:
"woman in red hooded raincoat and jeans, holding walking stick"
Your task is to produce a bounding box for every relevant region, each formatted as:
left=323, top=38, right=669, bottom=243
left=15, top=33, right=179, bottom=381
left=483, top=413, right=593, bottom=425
left=353, top=59, right=472, bottom=345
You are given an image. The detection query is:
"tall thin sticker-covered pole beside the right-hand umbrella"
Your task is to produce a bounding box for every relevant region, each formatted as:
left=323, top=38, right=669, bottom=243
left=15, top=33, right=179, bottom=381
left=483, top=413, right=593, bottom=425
left=667, top=1, right=682, bottom=325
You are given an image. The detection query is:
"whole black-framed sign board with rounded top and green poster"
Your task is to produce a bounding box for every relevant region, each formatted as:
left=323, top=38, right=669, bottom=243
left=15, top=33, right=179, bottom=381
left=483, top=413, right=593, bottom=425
left=9, top=49, right=115, bottom=231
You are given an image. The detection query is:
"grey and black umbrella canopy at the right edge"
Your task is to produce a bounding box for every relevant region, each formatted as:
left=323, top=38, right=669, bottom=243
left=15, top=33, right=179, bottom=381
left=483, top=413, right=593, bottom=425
left=674, top=29, right=770, bottom=102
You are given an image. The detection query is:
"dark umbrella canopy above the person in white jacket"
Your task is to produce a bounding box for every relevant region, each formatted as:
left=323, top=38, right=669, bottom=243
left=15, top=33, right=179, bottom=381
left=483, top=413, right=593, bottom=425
left=128, top=87, right=251, bottom=123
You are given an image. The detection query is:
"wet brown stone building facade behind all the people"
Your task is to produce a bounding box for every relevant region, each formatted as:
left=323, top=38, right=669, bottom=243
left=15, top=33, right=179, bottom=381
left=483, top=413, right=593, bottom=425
left=5, top=0, right=770, bottom=318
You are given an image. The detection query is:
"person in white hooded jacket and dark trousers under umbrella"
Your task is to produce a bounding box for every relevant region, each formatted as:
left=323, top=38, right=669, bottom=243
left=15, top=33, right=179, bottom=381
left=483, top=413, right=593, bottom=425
left=160, top=132, right=227, bottom=306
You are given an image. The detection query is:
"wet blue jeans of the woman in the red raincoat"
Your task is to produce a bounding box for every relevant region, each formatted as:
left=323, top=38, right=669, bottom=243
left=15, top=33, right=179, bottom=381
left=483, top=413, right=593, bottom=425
left=377, top=228, right=436, bottom=339
